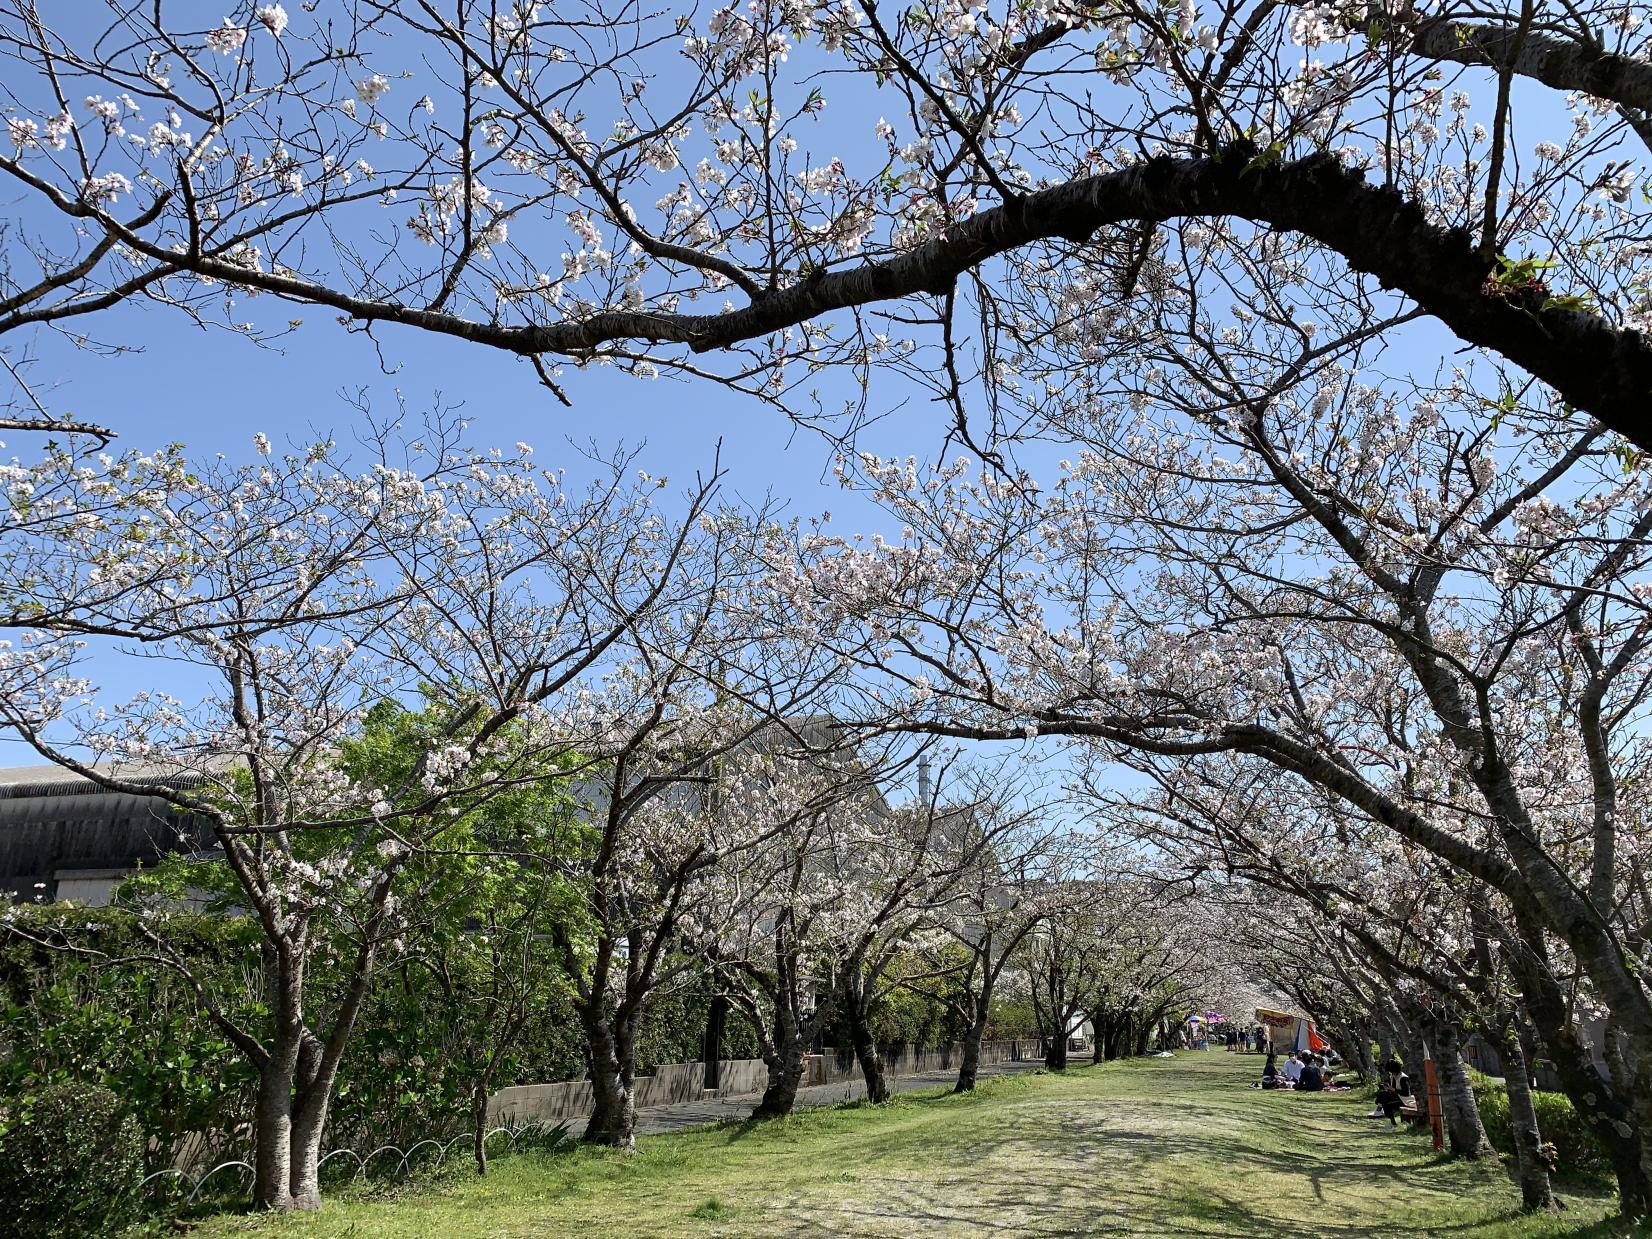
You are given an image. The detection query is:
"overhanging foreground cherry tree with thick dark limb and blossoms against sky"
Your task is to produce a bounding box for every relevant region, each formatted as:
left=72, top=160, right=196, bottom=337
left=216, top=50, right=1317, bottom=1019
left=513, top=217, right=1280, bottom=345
left=0, top=0, right=1652, bottom=446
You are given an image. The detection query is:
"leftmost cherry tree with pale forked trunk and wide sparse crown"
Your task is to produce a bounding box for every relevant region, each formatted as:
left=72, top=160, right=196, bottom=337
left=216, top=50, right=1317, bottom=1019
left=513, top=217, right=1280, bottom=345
left=0, top=420, right=743, bottom=1209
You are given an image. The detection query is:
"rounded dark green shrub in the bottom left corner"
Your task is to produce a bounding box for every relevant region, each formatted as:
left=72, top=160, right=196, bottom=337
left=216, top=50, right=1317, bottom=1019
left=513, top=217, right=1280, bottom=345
left=0, top=1084, right=144, bottom=1239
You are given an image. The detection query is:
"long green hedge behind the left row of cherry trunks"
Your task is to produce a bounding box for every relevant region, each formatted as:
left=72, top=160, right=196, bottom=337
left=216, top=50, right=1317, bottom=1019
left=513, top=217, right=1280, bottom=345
left=0, top=909, right=773, bottom=1171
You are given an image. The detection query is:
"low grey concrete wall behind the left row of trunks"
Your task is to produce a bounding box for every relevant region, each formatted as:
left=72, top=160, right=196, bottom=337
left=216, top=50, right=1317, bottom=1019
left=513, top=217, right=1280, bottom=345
left=487, top=1041, right=1037, bottom=1125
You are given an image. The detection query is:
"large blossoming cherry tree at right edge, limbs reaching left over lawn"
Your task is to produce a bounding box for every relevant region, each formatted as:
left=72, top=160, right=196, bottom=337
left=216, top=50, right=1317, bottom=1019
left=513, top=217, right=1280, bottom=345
left=788, top=386, right=1652, bottom=1211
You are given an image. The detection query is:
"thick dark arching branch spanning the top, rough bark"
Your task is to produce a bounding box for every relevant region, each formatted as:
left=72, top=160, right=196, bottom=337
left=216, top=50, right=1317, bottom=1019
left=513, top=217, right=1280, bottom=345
left=87, top=142, right=1652, bottom=448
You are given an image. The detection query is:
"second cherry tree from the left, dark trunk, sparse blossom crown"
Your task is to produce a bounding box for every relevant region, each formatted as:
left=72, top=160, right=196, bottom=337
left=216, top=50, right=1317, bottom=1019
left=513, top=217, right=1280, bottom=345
left=557, top=713, right=861, bottom=1148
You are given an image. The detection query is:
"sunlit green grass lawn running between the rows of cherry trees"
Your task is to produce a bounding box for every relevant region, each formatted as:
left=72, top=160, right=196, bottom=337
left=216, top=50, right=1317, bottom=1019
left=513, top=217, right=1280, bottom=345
left=198, top=1052, right=1627, bottom=1239
